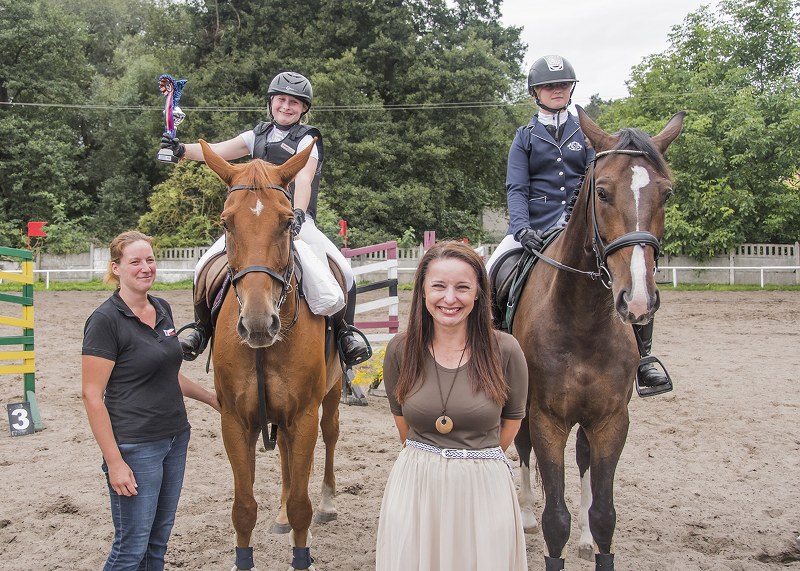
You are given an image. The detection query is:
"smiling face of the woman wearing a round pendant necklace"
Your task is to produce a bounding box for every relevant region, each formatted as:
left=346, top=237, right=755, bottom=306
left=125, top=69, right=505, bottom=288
left=424, top=258, right=478, bottom=328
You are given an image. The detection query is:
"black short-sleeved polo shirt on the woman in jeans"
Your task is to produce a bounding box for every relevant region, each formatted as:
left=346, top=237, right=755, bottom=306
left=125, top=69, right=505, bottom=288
left=82, top=290, right=189, bottom=444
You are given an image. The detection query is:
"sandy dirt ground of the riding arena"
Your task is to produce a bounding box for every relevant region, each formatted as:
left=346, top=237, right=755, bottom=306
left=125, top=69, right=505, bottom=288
left=0, top=291, right=800, bottom=571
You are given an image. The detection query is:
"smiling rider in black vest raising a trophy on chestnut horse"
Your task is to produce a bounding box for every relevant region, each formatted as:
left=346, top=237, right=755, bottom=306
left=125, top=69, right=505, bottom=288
left=161, top=71, right=372, bottom=366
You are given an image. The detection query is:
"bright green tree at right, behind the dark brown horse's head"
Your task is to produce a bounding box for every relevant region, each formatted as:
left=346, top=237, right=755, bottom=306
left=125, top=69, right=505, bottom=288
left=601, top=0, right=800, bottom=258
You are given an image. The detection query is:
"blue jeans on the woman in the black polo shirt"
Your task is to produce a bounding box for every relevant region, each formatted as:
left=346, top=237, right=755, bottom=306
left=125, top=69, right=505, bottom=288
left=103, top=430, right=191, bottom=571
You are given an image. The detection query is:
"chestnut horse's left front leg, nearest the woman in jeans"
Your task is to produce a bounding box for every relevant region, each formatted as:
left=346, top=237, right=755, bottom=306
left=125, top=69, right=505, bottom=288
left=222, top=410, right=258, bottom=571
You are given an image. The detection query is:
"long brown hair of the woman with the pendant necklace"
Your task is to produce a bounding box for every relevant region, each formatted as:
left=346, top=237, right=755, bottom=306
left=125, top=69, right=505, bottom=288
left=395, top=241, right=508, bottom=405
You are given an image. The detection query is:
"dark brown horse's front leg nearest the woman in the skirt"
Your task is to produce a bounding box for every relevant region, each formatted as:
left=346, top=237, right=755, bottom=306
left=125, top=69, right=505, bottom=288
left=530, top=411, right=571, bottom=571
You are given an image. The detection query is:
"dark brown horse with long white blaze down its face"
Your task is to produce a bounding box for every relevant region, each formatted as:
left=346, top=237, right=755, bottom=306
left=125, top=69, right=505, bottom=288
left=512, top=107, right=685, bottom=571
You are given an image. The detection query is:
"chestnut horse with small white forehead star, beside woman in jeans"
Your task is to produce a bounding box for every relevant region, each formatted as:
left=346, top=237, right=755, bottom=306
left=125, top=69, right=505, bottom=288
left=200, top=140, right=342, bottom=570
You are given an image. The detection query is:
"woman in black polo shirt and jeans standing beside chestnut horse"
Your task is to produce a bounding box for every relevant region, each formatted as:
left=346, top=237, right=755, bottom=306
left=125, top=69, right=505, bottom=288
left=82, top=231, right=220, bottom=571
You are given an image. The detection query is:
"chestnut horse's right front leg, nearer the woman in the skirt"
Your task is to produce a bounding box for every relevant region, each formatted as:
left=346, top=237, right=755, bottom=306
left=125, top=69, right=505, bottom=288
left=285, top=404, right=319, bottom=569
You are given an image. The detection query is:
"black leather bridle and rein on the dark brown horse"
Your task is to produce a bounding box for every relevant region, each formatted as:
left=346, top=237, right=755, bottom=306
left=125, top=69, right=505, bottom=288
left=533, top=149, right=661, bottom=289
